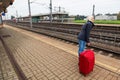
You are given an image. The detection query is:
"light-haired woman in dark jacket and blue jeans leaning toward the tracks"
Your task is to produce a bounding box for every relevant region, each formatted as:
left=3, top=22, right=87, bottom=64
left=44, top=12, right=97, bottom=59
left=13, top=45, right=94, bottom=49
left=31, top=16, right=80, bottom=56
left=78, top=16, right=94, bottom=56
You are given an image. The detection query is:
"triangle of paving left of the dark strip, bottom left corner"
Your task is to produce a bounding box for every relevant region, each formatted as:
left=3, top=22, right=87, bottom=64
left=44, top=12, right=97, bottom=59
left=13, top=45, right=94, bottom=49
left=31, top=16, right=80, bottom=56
left=0, top=34, right=18, bottom=80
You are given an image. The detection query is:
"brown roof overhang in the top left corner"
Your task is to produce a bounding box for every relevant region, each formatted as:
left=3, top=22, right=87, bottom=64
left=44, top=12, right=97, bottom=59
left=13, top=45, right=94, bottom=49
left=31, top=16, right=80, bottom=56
left=0, top=0, right=14, bottom=13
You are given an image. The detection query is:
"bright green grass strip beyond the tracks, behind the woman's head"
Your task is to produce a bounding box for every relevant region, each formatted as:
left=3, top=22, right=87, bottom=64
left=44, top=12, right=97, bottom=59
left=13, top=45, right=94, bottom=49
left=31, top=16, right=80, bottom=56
left=74, top=20, right=120, bottom=24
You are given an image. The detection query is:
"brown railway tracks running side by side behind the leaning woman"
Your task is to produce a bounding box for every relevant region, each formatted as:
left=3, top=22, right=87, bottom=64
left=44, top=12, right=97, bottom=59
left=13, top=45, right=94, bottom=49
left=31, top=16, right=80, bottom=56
left=4, top=22, right=120, bottom=54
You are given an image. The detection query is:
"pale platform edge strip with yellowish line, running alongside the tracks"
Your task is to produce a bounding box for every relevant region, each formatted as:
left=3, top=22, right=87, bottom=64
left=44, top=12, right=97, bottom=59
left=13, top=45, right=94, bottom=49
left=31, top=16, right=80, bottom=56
left=7, top=26, right=120, bottom=74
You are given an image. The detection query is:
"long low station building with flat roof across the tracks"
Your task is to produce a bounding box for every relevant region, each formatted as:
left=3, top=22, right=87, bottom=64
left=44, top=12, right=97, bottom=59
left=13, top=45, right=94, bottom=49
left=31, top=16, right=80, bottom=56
left=19, top=12, right=68, bottom=22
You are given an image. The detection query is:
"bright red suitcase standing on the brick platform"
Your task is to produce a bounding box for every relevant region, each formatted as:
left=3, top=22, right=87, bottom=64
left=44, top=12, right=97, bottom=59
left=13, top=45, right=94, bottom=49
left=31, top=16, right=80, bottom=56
left=79, top=50, right=95, bottom=76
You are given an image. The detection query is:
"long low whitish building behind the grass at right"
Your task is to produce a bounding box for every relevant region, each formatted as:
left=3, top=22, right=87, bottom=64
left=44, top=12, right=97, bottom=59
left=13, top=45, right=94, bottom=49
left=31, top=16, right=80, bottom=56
left=95, top=15, right=117, bottom=20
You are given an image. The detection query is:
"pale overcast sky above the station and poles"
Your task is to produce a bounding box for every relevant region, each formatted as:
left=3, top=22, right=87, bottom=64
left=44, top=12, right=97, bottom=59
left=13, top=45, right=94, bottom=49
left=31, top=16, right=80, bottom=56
left=7, top=0, right=120, bottom=16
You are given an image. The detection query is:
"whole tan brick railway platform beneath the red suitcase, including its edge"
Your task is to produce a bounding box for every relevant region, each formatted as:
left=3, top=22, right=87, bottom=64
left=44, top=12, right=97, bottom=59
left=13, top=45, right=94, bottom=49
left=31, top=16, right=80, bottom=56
left=0, top=25, right=120, bottom=80
